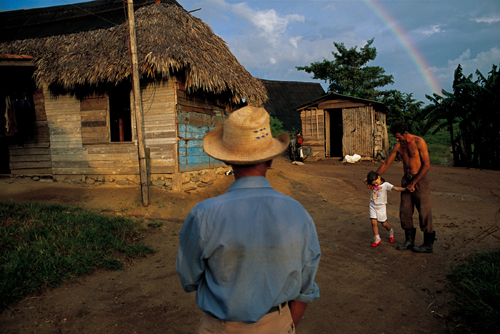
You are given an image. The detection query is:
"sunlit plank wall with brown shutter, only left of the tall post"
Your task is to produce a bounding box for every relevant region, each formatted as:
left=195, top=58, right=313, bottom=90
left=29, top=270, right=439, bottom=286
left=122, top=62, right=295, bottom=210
left=46, top=87, right=139, bottom=175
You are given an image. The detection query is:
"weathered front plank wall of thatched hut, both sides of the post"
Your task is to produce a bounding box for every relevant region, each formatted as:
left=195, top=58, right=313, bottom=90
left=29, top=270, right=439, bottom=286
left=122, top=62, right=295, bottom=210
left=46, top=82, right=176, bottom=175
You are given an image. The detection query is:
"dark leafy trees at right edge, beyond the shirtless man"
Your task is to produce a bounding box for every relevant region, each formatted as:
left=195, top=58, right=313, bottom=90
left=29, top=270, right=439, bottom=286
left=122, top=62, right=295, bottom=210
left=424, top=65, right=500, bottom=169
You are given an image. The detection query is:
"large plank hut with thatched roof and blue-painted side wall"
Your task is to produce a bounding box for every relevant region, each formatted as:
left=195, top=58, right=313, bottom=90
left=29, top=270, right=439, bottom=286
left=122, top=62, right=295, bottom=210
left=0, top=0, right=267, bottom=189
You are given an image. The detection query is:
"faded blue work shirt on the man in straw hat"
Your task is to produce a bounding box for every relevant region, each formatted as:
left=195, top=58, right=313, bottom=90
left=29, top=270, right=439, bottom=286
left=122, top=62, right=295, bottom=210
left=175, top=177, right=321, bottom=323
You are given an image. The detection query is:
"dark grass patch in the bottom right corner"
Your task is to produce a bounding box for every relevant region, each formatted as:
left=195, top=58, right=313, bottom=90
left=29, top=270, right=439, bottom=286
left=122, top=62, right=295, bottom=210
left=447, top=249, right=500, bottom=334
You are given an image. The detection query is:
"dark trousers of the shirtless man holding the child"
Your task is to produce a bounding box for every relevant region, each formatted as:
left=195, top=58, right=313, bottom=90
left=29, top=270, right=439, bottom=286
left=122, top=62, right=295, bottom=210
left=399, top=175, right=433, bottom=233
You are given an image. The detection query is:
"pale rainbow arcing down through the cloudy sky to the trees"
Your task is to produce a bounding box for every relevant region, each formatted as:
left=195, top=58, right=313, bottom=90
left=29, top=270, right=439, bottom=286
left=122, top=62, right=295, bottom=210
left=363, top=0, right=441, bottom=95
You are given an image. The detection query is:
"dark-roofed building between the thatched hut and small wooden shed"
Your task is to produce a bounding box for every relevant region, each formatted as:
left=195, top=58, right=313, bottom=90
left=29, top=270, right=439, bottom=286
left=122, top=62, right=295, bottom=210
left=261, top=79, right=325, bottom=133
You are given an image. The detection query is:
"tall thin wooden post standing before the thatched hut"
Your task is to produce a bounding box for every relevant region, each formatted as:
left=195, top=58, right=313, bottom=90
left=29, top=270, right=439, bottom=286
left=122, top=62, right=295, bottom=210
left=127, top=0, right=149, bottom=206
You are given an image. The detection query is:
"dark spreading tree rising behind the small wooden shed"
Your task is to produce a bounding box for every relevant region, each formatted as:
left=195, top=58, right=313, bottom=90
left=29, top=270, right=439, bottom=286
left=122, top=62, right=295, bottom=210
left=296, top=38, right=394, bottom=100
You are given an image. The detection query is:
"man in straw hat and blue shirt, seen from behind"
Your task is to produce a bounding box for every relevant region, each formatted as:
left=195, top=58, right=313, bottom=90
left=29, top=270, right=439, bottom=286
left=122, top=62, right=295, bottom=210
left=176, top=106, right=321, bottom=334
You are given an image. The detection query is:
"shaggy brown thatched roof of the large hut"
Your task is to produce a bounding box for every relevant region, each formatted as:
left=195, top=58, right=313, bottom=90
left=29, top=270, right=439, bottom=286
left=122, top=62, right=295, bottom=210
left=0, top=0, right=266, bottom=103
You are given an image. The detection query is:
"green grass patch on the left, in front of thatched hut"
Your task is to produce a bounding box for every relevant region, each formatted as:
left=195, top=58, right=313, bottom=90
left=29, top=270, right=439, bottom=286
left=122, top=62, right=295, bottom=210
left=0, top=202, right=154, bottom=311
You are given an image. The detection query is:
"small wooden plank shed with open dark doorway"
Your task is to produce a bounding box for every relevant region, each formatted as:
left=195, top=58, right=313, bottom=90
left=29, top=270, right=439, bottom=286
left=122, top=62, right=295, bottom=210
left=296, top=93, right=389, bottom=160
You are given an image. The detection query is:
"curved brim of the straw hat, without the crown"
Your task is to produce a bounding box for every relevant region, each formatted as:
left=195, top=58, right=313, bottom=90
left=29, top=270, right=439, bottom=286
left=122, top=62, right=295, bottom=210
left=203, top=125, right=290, bottom=165
